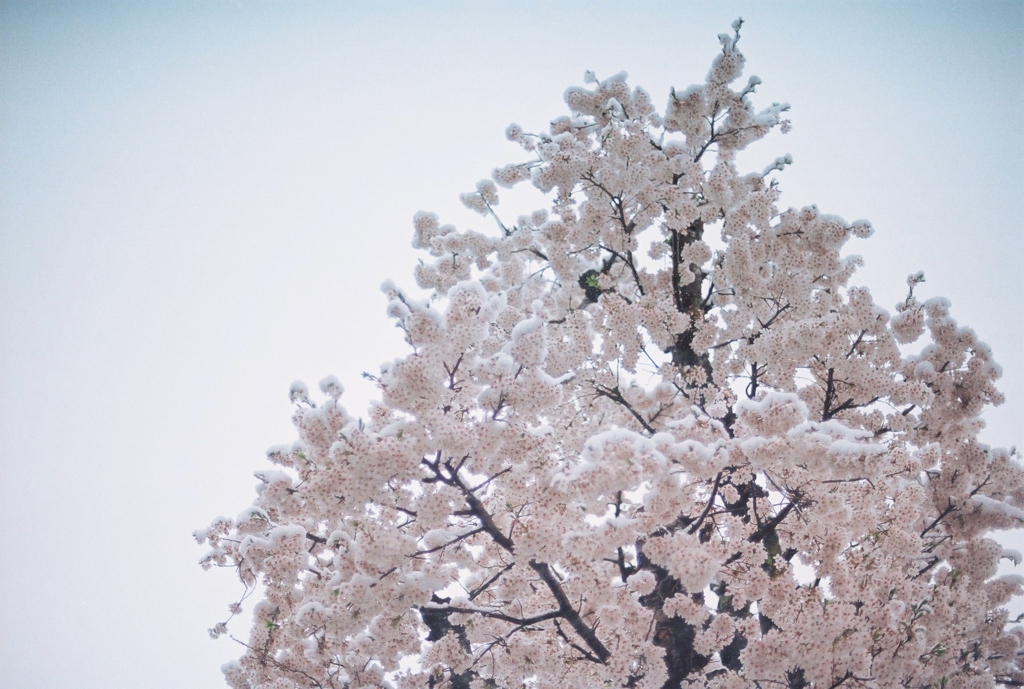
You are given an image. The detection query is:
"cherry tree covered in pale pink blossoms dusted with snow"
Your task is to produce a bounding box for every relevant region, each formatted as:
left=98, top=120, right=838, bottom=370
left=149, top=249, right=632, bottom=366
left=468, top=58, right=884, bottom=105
left=196, top=21, right=1024, bottom=689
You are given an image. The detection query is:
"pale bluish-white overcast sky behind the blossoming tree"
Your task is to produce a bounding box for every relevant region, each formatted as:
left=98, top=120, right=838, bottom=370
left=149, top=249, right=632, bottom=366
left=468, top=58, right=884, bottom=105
left=0, top=0, right=1024, bottom=689
